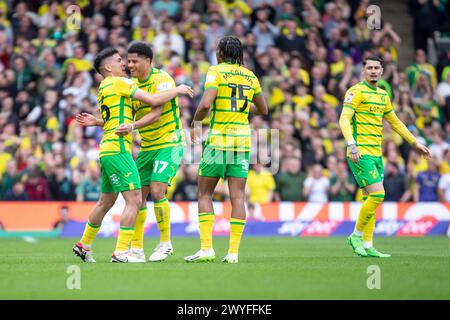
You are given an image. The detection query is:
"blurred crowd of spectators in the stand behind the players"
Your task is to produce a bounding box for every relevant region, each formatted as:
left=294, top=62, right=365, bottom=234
left=0, top=0, right=450, bottom=204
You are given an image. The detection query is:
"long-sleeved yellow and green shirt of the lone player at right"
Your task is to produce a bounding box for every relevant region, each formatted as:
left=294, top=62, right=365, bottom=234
left=342, top=81, right=415, bottom=156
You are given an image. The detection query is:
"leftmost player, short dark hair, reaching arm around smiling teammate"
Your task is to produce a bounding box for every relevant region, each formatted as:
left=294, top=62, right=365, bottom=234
left=73, top=48, right=193, bottom=262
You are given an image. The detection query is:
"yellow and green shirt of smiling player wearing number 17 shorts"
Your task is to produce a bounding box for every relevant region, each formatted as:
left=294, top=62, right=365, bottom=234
left=133, top=68, right=186, bottom=151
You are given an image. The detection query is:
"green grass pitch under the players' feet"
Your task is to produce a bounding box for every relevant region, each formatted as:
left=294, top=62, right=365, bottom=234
left=0, top=237, right=450, bottom=300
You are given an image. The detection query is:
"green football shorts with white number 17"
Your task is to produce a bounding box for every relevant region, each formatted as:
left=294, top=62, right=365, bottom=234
left=136, top=147, right=184, bottom=186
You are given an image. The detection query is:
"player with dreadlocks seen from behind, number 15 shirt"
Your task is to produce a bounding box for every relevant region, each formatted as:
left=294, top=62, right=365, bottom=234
left=185, top=36, right=268, bottom=263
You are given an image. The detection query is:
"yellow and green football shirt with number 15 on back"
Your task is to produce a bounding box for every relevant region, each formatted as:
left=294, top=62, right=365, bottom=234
left=205, top=63, right=262, bottom=152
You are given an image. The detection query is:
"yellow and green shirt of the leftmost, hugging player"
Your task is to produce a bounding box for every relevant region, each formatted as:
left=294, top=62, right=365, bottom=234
left=98, top=77, right=138, bottom=157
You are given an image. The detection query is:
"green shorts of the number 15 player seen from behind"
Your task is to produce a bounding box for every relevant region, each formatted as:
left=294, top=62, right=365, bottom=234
left=198, top=146, right=250, bottom=179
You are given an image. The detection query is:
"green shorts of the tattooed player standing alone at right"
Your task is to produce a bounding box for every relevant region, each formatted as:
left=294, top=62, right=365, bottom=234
left=347, top=155, right=384, bottom=188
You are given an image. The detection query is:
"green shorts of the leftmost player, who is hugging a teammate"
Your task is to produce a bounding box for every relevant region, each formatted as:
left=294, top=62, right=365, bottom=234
left=100, top=153, right=141, bottom=193
